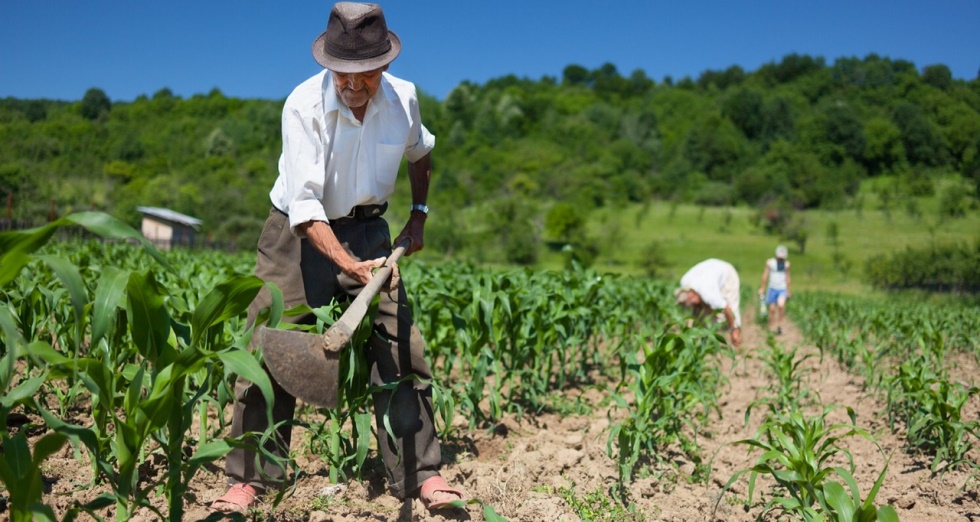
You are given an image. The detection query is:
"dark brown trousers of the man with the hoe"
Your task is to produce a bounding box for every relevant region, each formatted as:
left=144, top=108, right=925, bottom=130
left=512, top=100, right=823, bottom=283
left=225, top=208, right=442, bottom=498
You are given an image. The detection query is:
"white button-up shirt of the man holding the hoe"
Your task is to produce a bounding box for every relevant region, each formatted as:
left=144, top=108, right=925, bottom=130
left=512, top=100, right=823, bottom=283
left=269, top=70, right=435, bottom=234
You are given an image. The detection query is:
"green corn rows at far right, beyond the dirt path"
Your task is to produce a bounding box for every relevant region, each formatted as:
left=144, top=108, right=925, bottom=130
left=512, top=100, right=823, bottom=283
left=791, top=288, right=980, bottom=473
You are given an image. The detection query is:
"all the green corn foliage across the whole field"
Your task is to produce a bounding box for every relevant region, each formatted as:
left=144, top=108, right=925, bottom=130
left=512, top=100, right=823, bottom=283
left=0, top=216, right=980, bottom=520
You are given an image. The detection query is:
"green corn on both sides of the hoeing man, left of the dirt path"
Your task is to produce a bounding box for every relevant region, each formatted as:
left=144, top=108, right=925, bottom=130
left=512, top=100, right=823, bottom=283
left=0, top=213, right=724, bottom=520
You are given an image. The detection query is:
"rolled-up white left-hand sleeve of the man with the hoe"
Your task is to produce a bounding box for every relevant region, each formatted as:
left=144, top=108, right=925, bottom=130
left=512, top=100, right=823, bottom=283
left=279, top=100, right=327, bottom=234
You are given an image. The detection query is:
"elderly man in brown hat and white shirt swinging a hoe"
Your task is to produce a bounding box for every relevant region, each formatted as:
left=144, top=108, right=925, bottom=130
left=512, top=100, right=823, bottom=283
left=212, top=2, right=463, bottom=512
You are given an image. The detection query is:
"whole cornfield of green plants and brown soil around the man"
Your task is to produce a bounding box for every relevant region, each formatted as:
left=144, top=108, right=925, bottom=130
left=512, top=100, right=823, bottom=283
left=0, top=214, right=980, bottom=521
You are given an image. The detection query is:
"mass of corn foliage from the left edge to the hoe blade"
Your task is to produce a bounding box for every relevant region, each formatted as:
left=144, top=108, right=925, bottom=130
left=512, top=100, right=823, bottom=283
left=0, top=213, right=272, bottom=520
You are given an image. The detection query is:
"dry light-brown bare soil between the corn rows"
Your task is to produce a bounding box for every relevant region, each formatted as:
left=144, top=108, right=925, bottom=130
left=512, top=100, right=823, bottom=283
left=13, top=304, right=980, bottom=522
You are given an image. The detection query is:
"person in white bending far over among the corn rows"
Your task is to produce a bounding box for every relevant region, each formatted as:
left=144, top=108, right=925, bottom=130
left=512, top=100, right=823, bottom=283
left=674, top=259, right=742, bottom=347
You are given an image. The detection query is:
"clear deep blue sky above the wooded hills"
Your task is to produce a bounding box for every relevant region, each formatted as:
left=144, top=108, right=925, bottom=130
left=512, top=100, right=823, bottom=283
left=0, top=0, right=980, bottom=101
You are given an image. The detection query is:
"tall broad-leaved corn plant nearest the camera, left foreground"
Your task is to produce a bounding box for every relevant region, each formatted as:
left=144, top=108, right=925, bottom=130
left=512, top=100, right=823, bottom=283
left=0, top=213, right=282, bottom=520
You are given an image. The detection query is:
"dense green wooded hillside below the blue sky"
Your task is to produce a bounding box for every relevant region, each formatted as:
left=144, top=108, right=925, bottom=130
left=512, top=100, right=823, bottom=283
left=0, top=54, right=980, bottom=252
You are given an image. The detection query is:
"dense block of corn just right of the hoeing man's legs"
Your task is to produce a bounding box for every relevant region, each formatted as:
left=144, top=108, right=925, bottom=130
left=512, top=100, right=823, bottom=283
left=403, top=263, right=669, bottom=428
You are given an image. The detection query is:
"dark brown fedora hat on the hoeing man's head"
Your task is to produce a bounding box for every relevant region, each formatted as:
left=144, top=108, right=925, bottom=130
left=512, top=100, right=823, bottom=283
left=313, top=2, right=402, bottom=73
